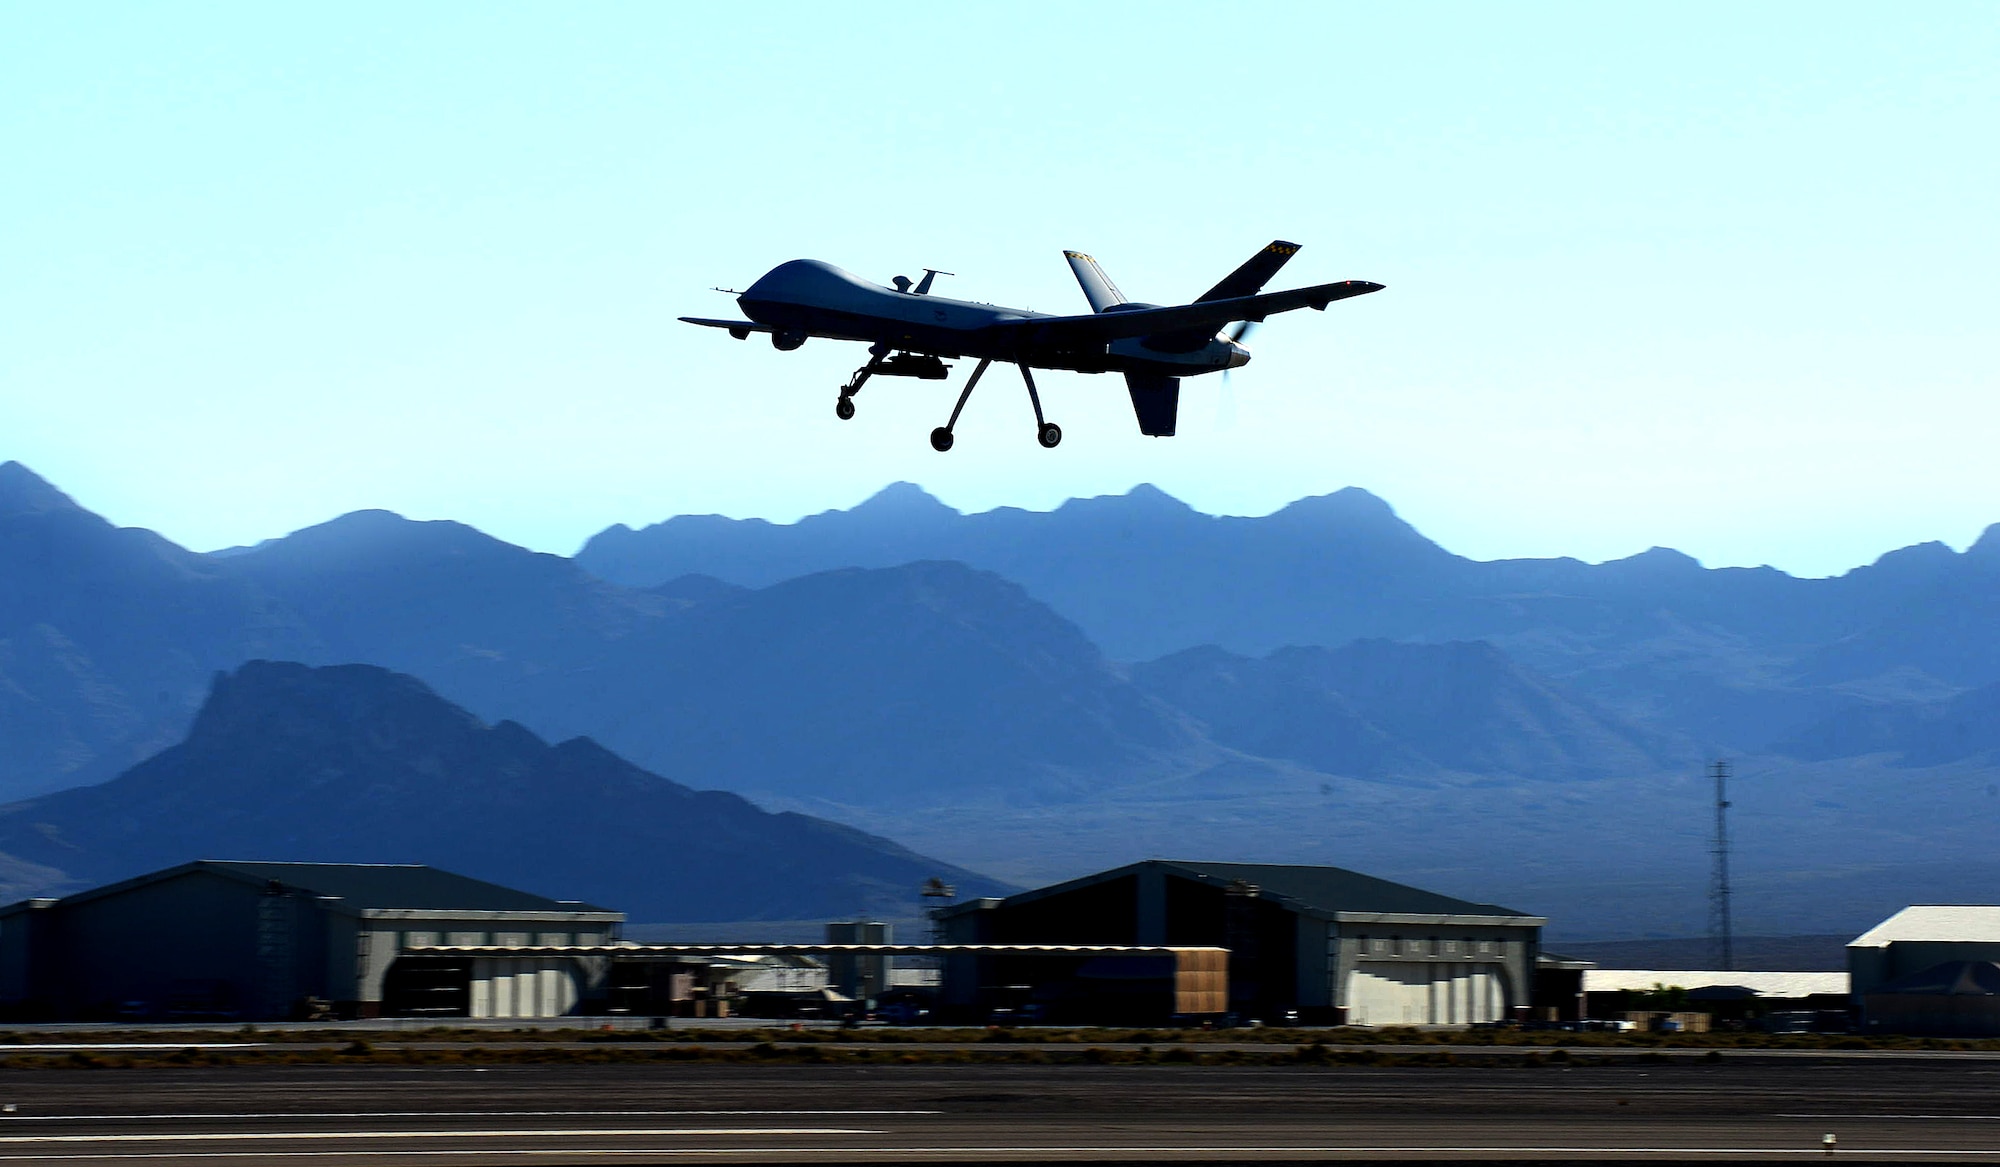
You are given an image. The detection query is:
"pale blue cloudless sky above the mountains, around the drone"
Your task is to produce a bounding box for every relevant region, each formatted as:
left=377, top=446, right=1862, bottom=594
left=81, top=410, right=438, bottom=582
left=0, top=2, right=2000, bottom=574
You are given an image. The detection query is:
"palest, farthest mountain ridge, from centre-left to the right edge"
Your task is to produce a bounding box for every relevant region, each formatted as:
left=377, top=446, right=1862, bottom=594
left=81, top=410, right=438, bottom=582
left=576, top=484, right=2000, bottom=749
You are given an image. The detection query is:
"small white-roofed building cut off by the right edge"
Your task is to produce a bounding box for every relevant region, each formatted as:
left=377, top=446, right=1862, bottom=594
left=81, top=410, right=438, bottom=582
left=1848, top=903, right=2000, bottom=1037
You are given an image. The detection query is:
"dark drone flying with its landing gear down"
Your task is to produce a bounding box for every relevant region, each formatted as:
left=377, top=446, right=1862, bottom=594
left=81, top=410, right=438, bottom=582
left=682, top=240, right=1382, bottom=452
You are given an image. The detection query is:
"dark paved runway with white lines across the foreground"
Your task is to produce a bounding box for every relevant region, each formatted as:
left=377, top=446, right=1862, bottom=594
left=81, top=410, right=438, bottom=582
left=0, top=1059, right=2000, bottom=1167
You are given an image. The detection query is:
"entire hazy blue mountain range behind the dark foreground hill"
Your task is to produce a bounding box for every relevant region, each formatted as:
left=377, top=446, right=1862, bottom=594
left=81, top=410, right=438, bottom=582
left=0, top=464, right=2000, bottom=933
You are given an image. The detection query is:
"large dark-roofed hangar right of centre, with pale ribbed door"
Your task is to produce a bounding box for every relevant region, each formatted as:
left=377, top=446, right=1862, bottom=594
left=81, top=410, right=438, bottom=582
left=938, top=859, right=1548, bottom=1025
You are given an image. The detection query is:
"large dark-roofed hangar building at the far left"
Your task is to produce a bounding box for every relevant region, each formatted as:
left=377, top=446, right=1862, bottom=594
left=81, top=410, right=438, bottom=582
left=0, top=859, right=624, bottom=1019
